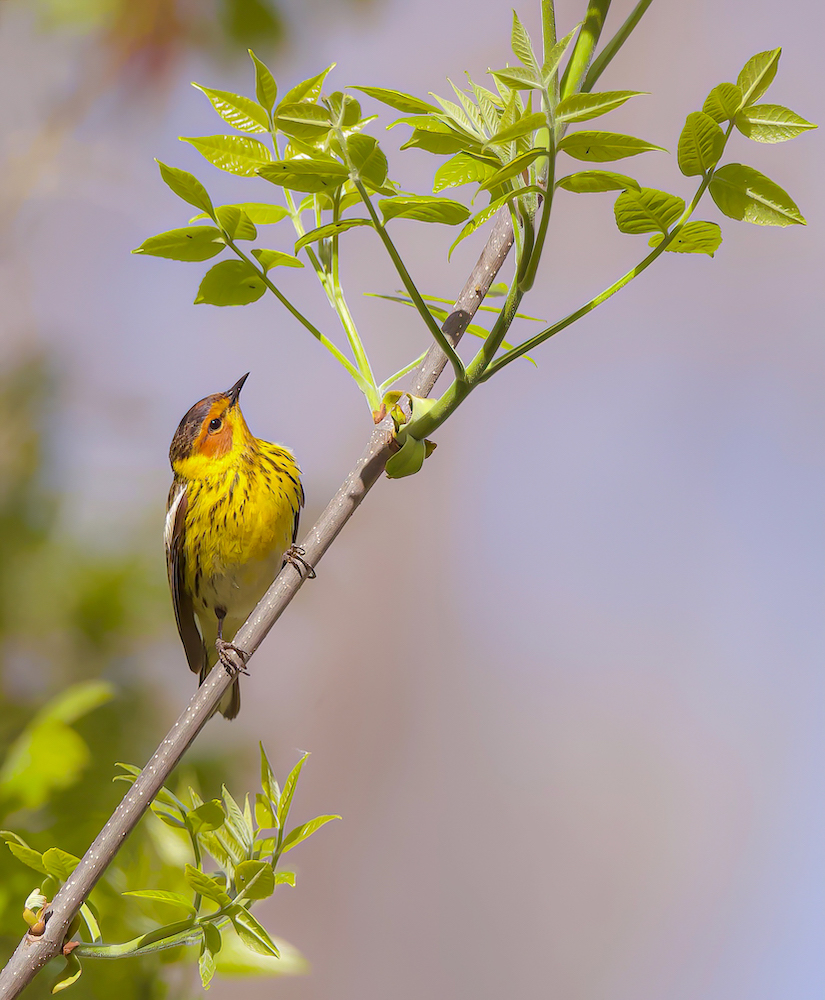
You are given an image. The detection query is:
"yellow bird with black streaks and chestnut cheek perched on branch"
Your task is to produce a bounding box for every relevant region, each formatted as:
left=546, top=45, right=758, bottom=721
left=164, top=372, right=302, bottom=719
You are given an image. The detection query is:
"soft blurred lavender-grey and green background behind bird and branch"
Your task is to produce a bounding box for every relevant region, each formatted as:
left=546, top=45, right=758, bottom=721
left=0, top=0, right=825, bottom=1000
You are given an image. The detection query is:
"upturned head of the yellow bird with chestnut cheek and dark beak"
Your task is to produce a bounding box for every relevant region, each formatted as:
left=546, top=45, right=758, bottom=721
left=169, top=372, right=255, bottom=479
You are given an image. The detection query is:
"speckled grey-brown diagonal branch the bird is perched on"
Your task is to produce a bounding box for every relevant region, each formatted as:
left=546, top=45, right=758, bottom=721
left=0, top=211, right=513, bottom=1000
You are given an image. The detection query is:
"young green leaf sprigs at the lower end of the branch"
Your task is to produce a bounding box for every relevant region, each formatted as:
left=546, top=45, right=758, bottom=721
left=5, top=748, right=340, bottom=993
